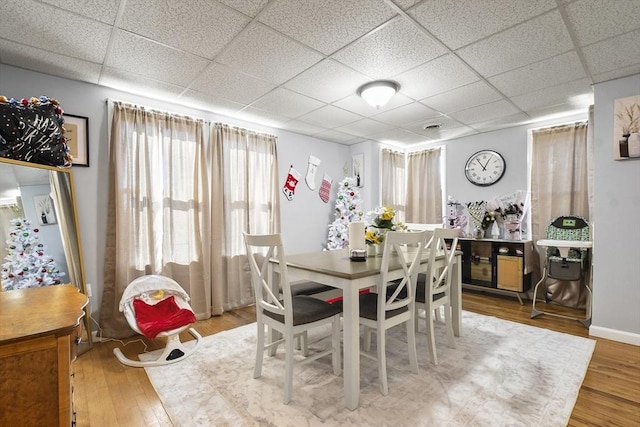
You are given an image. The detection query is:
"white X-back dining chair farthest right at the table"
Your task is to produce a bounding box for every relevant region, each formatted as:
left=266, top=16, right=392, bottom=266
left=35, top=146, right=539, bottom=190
left=415, top=228, right=460, bottom=365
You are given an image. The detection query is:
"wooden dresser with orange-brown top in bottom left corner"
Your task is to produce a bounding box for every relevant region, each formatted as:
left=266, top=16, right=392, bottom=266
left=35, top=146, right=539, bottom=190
left=0, top=285, right=88, bottom=427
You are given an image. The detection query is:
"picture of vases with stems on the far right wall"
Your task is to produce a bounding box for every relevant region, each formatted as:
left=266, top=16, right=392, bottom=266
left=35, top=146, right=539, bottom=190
left=613, top=95, right=640, bottom=160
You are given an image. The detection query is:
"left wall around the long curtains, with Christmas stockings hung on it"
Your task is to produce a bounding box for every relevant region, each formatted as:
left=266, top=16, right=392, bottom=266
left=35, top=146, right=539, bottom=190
left=0, top=65, right=350, bottom=318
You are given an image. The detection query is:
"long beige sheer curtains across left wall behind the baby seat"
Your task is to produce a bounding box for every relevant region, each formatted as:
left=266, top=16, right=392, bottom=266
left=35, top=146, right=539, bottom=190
left=100, top=102, right=279, bottom=338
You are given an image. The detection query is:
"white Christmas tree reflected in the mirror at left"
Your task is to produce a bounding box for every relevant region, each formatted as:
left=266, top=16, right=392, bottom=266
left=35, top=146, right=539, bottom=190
left=0, top=218, right=64, bottom=291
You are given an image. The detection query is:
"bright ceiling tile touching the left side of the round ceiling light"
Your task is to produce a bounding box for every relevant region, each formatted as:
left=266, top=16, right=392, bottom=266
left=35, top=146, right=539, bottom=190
left=284, top=59, right=369, bottom=102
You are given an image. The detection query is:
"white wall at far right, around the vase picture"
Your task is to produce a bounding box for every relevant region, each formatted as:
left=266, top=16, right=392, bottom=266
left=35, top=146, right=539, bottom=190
left=590, top=74, right=640, bottom=345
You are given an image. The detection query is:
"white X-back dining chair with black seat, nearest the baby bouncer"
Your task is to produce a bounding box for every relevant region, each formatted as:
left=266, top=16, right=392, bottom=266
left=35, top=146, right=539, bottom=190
left=244, top=233, right=342, bottom=404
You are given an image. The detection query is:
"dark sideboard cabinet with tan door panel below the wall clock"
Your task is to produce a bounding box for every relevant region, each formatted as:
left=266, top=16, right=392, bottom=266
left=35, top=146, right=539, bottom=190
left=458, top=238, right=533, bottom=303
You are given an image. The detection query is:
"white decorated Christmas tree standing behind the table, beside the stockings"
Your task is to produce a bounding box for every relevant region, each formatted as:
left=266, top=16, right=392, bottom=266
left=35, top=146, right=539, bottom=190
left=327, top=177, right=364, bottom=250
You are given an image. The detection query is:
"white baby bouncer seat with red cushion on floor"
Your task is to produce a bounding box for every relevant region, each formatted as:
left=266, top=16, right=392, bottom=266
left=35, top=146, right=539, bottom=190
left=113, top=275, right=202, bottom=367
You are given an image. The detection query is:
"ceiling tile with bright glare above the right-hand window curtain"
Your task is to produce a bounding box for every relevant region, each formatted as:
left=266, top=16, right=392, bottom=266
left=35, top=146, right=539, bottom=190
left=511, top=78, right=593, bottom=113
